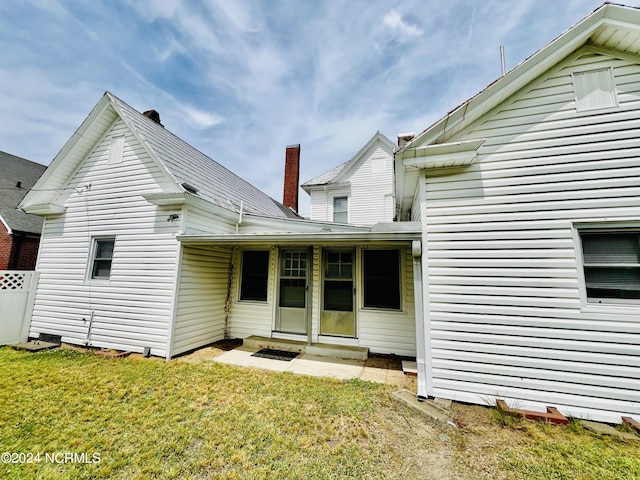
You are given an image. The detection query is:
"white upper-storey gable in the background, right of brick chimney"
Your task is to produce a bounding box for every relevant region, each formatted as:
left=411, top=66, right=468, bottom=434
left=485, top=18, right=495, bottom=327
left=301, top=132, right=395, bottom=225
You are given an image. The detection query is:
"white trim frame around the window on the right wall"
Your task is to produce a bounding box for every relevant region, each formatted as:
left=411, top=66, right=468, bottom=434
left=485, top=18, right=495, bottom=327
left=572, top=221, right=640, bottom=315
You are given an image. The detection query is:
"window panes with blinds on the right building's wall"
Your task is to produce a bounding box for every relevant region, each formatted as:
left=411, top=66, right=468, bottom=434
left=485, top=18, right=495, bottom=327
left=580, top=231, right=640, bottom=302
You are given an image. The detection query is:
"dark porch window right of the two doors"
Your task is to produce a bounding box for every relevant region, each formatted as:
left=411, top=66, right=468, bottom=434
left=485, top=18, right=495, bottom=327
left=362, top=250, right=400, bottom=310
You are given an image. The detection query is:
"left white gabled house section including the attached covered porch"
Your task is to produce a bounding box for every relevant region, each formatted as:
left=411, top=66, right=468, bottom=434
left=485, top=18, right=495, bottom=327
left=20, top=93, right=420, bottom=358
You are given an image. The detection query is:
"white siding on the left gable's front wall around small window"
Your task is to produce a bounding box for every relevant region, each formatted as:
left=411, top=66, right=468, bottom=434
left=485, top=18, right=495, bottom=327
left=30, top=121, right=179, bottom=356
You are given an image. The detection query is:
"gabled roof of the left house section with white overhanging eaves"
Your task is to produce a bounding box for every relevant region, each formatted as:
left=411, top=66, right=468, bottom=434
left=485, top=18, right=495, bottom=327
left=21, top=92, right=295, bottom=217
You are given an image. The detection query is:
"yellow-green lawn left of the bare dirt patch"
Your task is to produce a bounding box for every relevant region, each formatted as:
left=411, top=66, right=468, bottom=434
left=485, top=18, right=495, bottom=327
left=0, top=348, right=386, bottom=479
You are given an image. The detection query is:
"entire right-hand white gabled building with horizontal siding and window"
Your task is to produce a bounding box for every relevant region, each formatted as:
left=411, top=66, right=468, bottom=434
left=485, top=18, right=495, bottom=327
left=395, top=4, right=640, bottom=422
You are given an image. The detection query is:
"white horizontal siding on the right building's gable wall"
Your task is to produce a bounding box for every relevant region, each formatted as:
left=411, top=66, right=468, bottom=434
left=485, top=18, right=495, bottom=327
left=423, top=50, right=640, bottom=421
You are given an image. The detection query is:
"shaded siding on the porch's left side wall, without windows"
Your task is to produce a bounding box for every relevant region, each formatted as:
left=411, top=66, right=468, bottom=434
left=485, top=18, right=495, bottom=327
left=172, top=247, right=231, bottom=355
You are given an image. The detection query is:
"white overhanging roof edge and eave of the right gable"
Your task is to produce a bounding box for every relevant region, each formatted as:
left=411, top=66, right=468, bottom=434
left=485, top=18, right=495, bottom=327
left=395, top=3, right=640, bottom=217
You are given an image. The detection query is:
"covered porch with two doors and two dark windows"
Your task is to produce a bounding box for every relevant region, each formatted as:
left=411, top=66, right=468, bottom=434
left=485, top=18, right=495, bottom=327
left=172, top=222, right=421, bottom=357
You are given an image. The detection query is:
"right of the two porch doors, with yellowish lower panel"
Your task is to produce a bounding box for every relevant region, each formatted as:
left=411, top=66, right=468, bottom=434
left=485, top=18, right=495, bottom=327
left=320, top=249, right=356, bottom=337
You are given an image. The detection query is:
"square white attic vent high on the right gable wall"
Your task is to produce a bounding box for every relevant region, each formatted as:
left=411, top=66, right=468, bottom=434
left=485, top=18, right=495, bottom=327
left=572, top=68, right=618, bottom=112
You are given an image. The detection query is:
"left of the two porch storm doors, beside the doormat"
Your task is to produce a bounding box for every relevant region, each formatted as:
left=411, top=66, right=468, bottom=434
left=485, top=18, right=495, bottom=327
left=276, top=250, right=310, bottom=334
